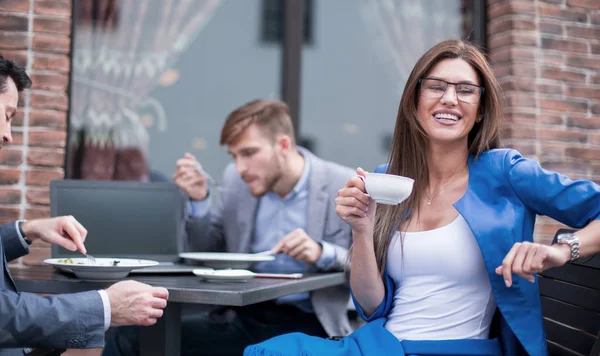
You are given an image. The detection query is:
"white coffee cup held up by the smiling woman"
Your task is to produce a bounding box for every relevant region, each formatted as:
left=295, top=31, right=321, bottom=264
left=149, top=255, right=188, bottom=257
left=359, top=173, right=415, bottom=205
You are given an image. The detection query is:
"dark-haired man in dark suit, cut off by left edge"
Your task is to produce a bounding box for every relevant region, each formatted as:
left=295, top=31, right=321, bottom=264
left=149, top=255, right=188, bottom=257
left=0, top=56, right=168, bottom=356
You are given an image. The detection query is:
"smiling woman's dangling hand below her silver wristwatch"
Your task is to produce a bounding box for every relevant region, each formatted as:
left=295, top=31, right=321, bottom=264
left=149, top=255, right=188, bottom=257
left=496, top=242, right=571, bottom=287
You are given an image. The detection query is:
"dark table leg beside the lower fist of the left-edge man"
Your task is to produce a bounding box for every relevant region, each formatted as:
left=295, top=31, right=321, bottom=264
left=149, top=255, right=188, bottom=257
left=140, top=302, right=181, bottom=356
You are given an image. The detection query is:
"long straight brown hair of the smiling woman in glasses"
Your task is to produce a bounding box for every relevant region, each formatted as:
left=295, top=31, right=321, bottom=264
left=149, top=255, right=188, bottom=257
left=373, top=40, right=503, bottom=274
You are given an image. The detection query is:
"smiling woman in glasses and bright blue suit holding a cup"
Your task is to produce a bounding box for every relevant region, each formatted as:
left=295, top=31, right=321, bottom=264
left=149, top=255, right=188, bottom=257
left=245, top=40, right=600, bottom=356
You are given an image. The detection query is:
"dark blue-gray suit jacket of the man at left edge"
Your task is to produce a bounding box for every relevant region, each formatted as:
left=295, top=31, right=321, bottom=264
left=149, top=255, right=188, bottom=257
left=0, top=223, right=104, bottom=356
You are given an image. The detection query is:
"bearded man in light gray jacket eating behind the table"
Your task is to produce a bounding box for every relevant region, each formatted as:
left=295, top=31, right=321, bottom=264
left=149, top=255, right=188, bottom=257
left=105, top=100, right=354, bottom=355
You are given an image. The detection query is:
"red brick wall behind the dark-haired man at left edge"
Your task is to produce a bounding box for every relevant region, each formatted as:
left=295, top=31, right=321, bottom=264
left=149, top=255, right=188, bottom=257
left=0, top=0, right=71, bottom=263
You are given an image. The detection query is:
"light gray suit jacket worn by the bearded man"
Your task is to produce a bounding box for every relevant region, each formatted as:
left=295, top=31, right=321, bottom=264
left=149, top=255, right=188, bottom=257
left=187, top=147, right=354, bottom=336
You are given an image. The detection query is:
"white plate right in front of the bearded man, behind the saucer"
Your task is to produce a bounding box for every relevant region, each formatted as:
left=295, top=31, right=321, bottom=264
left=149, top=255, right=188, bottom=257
left=179, top=252, right=275, bottom=269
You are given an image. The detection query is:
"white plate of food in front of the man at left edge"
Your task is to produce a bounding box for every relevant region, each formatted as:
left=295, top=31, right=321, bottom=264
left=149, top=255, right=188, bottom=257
left=44, top=257, right=158, bottom=280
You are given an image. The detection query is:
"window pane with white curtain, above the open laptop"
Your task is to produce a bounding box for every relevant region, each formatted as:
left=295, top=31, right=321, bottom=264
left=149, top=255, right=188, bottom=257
left=67, top=0, right=281, bottom=180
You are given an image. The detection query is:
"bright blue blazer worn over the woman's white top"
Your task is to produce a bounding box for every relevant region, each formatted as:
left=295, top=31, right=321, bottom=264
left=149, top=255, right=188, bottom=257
left=353, top=149, right=600, bottom=355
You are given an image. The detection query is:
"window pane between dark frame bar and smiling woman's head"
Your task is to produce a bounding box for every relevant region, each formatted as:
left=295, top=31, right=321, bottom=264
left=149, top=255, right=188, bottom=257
left=300, top=0, right=472, bottom=170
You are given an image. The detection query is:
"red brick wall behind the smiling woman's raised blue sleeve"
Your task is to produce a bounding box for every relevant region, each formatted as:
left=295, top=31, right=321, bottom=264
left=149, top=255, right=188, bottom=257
left=487, top=0, right=600, bottom=245
